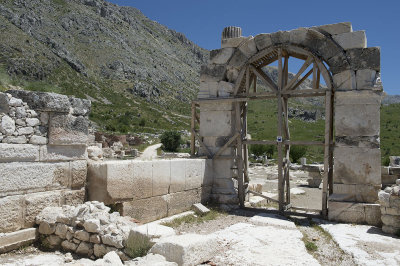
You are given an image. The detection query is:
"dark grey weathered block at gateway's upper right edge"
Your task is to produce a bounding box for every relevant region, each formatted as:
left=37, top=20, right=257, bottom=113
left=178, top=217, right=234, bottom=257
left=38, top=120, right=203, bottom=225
left=346, top=47, right=381, bottom=72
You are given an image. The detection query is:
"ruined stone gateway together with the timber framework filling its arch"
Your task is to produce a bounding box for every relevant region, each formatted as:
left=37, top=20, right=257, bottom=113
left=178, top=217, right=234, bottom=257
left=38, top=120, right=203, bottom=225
left=192, top=23, right=383, bottom=225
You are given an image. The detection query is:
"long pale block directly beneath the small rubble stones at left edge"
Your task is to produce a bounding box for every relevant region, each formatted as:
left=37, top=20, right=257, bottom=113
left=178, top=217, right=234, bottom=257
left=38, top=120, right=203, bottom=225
left=0, top=143, right=39, bottom=162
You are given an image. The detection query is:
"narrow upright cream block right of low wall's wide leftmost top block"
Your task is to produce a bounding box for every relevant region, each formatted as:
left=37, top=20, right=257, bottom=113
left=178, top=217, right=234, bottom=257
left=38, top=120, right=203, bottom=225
left=133, top=161, right=153, bottom=199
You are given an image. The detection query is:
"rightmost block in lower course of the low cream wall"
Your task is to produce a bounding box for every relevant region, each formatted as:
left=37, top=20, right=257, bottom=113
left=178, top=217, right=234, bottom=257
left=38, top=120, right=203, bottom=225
left=166, top=189, right=201, bottom=216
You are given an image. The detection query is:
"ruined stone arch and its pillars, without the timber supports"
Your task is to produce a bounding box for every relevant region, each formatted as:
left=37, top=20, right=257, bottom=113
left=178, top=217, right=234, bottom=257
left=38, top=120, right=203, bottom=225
left=196, top=23, right=382, bottom=224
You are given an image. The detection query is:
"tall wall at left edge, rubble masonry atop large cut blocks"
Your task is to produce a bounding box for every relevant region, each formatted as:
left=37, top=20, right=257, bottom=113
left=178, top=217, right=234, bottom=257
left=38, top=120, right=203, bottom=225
left=0, top=90, right=90, bottom=233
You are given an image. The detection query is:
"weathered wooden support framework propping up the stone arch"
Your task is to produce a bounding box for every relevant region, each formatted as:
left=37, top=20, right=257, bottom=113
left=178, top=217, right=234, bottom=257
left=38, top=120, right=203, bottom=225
left=191, top=45, right=334, bottom=216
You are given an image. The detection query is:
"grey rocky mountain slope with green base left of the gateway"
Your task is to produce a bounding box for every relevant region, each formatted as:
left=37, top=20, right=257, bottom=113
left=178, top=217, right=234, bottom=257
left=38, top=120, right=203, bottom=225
left=0, top=0, right=209, bottom=131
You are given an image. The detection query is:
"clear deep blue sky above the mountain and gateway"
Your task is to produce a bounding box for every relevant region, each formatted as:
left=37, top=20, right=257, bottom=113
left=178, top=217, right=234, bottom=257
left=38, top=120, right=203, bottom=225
left=110, top=0, right=400, bottom=94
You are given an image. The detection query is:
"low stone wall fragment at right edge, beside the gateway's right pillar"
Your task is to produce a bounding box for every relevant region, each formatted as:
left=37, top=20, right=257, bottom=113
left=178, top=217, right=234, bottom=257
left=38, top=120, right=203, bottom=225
left=379, top=183, right=400, bottom=236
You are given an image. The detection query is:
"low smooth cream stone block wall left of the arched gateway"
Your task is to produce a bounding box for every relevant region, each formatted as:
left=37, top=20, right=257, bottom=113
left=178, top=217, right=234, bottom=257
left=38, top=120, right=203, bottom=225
left=87, top=159, right=213, bottom=222
